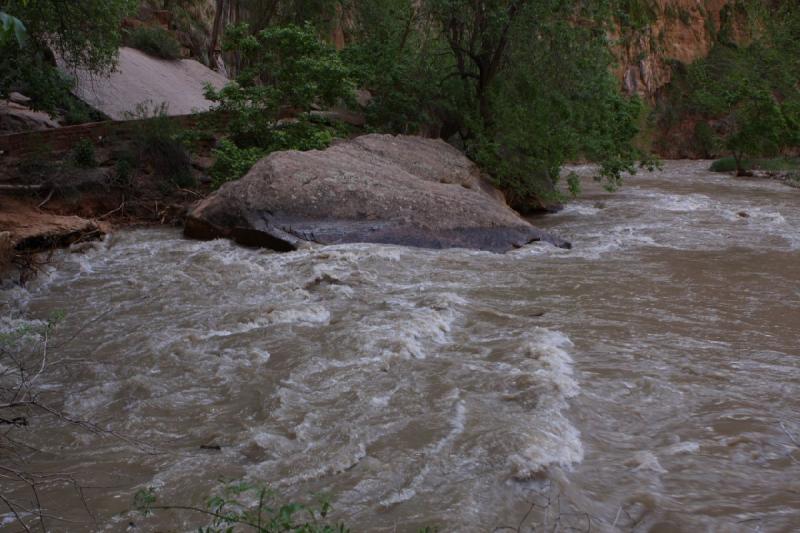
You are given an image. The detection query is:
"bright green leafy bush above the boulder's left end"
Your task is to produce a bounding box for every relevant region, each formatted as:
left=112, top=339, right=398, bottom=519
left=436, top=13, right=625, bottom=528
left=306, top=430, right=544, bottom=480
left=206, top=25, right=354, bottom=151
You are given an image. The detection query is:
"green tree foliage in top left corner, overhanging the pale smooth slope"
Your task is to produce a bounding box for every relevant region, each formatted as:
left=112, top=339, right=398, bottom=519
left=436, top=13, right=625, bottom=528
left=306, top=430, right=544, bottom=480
left=0, top=0, right=137, bottom=111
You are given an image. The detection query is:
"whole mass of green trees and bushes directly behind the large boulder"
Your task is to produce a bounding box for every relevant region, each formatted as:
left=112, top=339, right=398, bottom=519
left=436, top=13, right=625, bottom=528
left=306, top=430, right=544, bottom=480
left=197, top=0, right=652, bottom=211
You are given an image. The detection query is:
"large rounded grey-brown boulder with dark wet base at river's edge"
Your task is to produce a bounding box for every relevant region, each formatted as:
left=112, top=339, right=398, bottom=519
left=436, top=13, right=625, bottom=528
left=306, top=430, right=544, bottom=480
left=185, top=135, right=569, bottom=252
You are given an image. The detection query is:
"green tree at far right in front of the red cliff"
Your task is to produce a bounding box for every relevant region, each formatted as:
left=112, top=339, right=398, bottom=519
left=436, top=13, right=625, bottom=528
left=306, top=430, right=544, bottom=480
left=656, top=0, right=800, bottom=173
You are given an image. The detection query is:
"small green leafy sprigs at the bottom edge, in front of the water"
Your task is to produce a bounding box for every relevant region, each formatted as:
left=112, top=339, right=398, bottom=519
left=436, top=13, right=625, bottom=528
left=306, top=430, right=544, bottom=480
left=134, top=482, right=349, bottom=533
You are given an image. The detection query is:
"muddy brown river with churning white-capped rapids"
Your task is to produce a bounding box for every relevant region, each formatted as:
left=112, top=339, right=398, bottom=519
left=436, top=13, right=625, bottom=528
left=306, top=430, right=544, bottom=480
left=0, top=162, right=800, bottom=532
